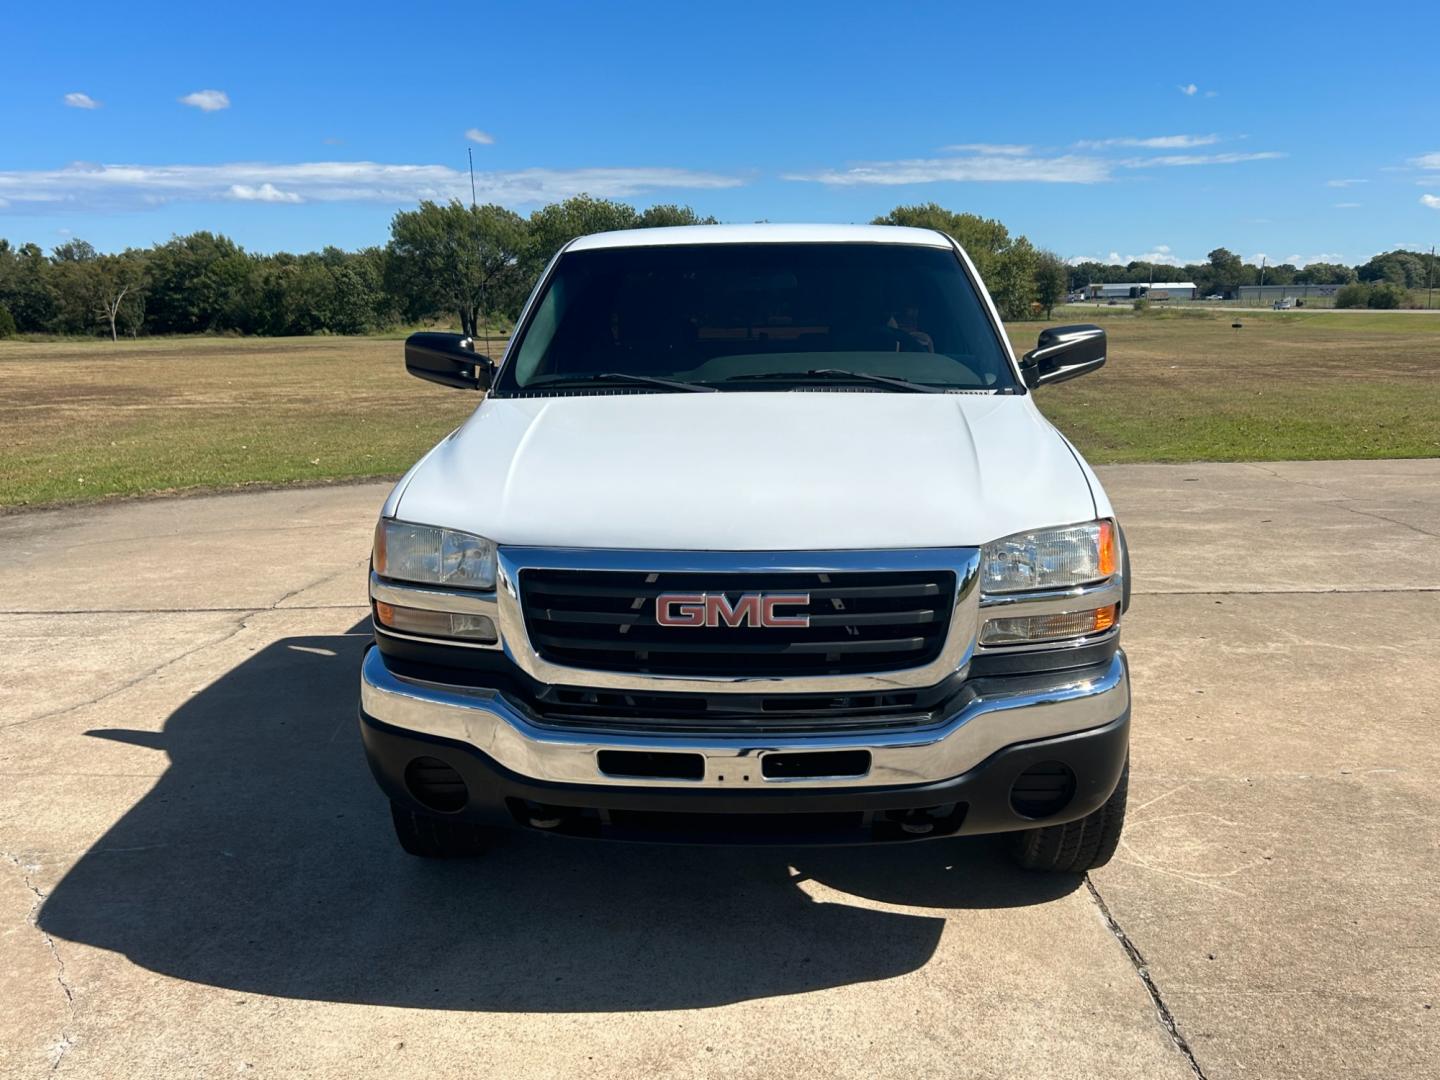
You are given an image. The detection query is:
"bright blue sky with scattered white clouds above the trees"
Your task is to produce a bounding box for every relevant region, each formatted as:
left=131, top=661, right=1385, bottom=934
left=8, top=0, right=1440, bottom=269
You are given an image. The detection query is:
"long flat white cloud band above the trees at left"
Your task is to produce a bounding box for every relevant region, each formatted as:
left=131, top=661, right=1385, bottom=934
left=0, top=161, right=742, bottom=210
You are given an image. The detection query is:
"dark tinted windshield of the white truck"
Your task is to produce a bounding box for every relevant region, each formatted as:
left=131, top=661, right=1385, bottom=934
left=495, top=243, right=1015, bottom=396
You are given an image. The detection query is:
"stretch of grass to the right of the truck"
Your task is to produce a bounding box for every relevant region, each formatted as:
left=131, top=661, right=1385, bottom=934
left=1009, top=308, right=1440, bottom=464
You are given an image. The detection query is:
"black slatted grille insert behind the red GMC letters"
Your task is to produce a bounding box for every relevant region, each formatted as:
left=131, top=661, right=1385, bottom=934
left=520, top=569, right=956, bottom=675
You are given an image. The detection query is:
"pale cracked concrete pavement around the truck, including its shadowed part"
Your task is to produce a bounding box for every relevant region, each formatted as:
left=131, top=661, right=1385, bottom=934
left=0, top=461, right=1440, bottom=1080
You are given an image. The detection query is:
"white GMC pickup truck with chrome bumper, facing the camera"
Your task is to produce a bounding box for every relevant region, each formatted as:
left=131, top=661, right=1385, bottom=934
left=360, top=225, right=1130, bottom=873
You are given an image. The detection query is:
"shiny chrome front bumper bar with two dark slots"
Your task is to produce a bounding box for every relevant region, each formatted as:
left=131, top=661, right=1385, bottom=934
left=360, top=649, right=1130, bottom=791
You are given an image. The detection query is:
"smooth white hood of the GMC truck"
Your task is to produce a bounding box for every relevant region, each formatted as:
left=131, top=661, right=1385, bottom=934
left=389, top=392, right=1096, bottom=552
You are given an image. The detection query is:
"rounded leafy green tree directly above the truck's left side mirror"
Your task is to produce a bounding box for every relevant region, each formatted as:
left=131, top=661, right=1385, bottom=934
left=387, top=200, right=527, bottom=337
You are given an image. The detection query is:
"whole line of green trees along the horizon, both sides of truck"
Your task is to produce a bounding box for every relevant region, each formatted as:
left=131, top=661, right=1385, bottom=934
left=0, top=194, right=1440, bottom=340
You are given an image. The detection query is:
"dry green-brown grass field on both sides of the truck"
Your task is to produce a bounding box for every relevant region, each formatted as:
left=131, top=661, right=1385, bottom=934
left=0, top=307, right=1440, bottom=507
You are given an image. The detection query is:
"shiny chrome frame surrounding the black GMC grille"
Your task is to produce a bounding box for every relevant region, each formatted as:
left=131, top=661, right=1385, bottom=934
left=495, top=547, right=981, bottom=694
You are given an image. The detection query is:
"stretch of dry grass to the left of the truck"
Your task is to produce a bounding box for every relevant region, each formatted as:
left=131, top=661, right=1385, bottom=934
left=0, top=337, right=477, bottom=507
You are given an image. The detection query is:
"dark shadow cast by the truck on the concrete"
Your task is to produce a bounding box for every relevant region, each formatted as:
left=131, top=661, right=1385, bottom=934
left=39, top=622, right=1080, bottom=1012
